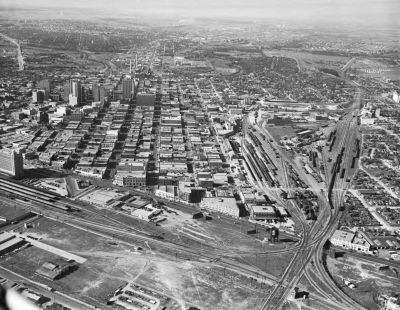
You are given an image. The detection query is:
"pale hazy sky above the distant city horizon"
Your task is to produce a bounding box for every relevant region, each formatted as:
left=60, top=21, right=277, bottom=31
left=0, top=0, right=400, bottom=27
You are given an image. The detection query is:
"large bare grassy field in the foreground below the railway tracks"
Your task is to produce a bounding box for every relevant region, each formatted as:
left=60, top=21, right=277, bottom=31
left=2, top=218, right=269, bottom=309
